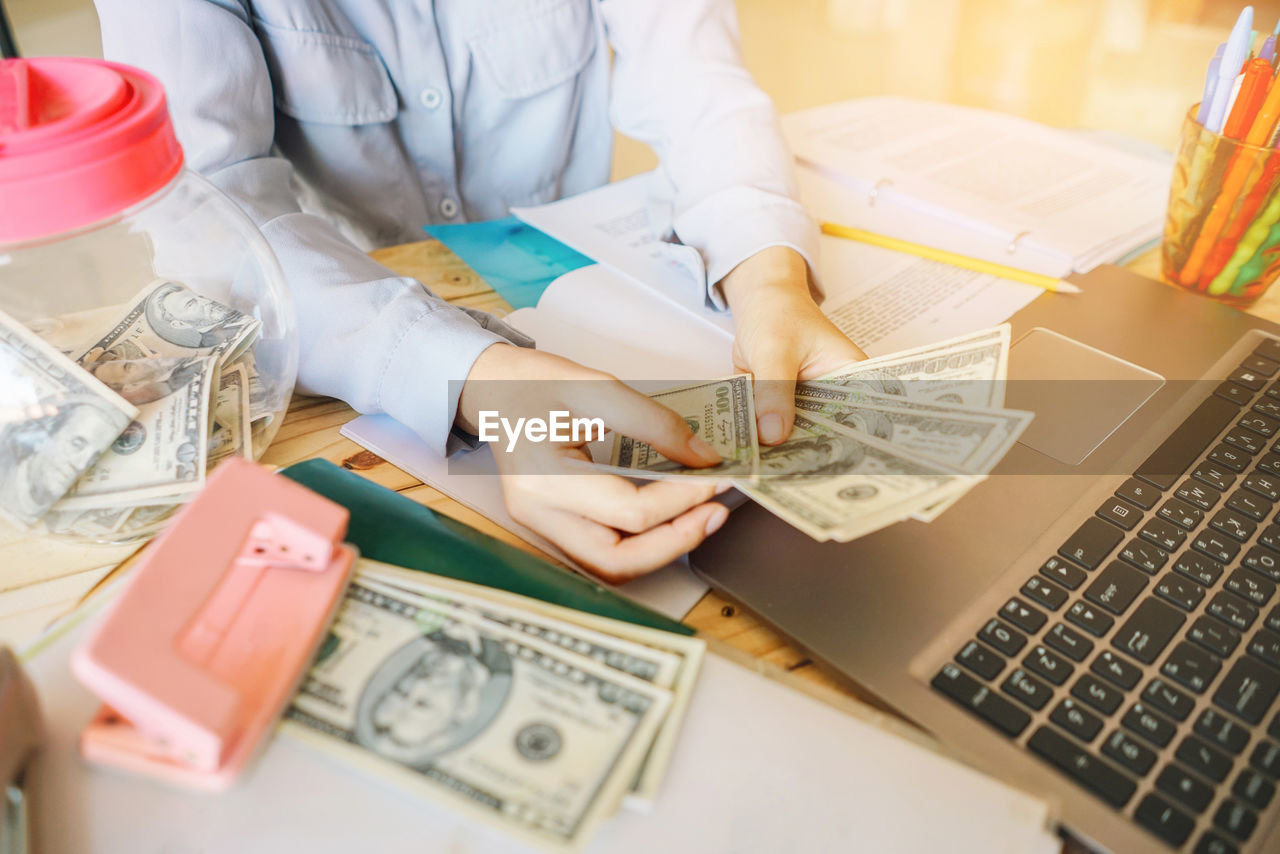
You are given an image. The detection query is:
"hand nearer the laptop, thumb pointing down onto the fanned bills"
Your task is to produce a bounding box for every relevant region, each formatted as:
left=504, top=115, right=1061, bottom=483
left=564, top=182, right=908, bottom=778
left=721, top=246, right=867, bottom=444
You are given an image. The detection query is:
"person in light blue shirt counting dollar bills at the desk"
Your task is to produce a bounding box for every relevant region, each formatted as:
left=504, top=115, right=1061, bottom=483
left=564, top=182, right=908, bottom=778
left=96, top=0, right=863, bottom=583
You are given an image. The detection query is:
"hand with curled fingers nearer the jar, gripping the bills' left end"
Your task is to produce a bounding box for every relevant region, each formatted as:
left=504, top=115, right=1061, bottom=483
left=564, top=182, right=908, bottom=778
left=457, top=344, right=728, bottom=584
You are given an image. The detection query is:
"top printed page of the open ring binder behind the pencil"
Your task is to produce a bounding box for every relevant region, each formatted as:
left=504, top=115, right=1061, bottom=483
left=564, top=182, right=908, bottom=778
left=783, top=97, right=1170, bottom=270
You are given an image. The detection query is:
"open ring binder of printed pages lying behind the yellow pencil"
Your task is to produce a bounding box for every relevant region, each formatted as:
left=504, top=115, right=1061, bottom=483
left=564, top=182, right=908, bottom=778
left=783, top=97, right=1171, bottom=277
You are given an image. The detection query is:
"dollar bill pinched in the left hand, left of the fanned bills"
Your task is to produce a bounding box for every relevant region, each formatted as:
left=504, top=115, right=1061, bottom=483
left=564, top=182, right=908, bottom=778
left=609, top=374, right=760, bottom=478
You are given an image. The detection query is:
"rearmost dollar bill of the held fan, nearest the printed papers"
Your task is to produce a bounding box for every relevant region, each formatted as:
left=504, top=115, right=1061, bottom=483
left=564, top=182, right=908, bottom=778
left=819, top=324, right=1009, bottom=408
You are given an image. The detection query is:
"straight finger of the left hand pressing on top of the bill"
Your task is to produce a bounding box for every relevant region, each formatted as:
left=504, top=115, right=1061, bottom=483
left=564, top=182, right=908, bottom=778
left=564, top=379, right=721, bottom=469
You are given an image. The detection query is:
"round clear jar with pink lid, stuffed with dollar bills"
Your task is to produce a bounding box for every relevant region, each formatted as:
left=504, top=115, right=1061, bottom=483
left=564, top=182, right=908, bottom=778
left=0, top=59, right=298, bottom=542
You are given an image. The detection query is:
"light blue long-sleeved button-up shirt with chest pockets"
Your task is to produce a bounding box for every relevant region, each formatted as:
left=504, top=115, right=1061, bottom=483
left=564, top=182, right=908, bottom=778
left=96, top=0, right=817, bottom=451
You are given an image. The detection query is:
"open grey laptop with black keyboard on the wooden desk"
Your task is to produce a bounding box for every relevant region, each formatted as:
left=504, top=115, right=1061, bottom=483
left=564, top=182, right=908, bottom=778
left=691, top=266, right=1280, bottom=854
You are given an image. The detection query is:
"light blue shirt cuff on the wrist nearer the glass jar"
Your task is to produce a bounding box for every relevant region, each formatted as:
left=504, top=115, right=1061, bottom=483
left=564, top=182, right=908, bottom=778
left=378, top=307, right=529, bottom=456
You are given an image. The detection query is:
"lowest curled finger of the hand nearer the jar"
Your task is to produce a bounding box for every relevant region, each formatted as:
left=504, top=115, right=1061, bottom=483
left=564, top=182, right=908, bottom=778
left=512, top=502, right=728, bottom=584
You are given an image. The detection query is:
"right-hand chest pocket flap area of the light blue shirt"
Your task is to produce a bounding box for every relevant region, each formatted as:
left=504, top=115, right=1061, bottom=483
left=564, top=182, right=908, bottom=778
left=468, top=0, right=599, bottom=99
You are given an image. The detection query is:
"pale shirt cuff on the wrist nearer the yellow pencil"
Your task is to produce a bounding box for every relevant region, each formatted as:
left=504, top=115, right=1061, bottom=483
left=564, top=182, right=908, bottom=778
left=675, top=187, right=818, bottom=311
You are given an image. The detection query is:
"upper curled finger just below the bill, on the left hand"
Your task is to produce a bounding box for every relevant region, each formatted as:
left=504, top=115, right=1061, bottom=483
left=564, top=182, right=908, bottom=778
left=504, top=474, right=728, bottom=534
